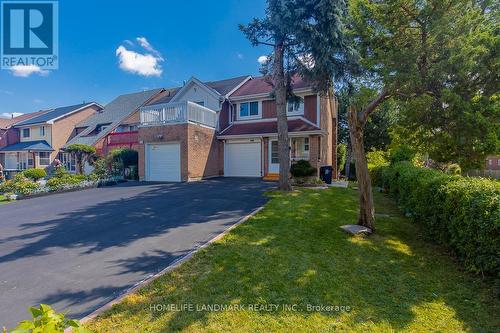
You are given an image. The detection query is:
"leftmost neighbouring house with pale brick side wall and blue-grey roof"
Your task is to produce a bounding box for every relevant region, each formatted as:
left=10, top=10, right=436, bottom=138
left=0, top=102, right=102, bottom=174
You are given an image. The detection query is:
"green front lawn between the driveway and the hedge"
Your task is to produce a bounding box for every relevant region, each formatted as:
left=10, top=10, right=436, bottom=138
left=89, top=188, right=500, bottom=332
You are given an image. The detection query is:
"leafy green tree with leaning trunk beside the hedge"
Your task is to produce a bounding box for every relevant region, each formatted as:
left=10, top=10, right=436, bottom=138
left=348, top=0, right=499, bottom=229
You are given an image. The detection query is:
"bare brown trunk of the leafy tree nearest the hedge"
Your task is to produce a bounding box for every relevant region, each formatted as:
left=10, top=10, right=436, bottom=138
left=348, top=106, right=375, bottom=231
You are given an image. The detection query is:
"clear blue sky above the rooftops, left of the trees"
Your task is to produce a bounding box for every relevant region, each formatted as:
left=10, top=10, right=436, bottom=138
left=0, top=0, right=270, bottom=114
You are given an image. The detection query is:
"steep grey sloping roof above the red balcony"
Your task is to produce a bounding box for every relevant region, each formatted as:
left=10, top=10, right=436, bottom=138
left=65, top=88, right=164, bottom=147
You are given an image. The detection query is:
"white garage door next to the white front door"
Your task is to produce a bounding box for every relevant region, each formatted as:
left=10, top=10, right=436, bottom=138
left=224, top=142, right=261, bottom=177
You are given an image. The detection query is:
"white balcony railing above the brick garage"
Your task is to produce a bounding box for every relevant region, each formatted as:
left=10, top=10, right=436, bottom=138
left=140, top=102, right=217, bottom=128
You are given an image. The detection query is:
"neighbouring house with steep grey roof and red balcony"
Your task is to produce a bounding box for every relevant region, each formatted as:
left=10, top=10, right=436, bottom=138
left=65, top=88, right=164, bottom=156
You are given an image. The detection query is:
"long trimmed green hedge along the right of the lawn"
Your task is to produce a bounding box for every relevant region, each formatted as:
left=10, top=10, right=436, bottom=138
left=373, top=162, right=500, bottom=278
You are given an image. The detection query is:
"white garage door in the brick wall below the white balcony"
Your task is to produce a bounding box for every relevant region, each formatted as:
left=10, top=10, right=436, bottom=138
left=146, top=143, right=181, bottom=182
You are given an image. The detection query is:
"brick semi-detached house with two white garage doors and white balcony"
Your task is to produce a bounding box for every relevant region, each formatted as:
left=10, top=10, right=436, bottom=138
left=139, top=76, right=336, bottom=181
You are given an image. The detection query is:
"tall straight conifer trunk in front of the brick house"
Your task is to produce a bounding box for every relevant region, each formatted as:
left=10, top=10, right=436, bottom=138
left=274, top=43, right=292, bottom=191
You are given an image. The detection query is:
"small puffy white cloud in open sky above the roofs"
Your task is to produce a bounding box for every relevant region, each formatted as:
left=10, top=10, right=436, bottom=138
left=116, top=37, right=164, bottom=76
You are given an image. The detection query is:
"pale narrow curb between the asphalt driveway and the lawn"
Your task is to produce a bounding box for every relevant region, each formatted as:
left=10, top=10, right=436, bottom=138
left=78, top=206, right=264, bottom=324
